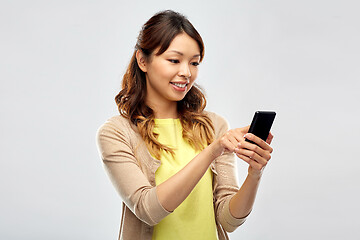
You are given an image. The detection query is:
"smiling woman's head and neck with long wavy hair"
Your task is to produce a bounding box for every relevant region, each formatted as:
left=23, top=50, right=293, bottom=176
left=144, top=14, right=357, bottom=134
left=115, top=11, right=213, bottom=161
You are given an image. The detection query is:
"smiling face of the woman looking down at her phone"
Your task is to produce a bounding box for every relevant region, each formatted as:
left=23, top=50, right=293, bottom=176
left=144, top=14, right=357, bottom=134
left=143, top=33, right=200, bottom=108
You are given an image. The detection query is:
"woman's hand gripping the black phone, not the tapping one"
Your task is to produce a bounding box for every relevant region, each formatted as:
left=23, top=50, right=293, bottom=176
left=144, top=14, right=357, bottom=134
left=234, top=133, right=273, bottom=177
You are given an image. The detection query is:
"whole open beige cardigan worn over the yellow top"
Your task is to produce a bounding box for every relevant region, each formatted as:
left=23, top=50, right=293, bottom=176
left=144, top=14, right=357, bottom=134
left=96, top=112, right=246, bottom=240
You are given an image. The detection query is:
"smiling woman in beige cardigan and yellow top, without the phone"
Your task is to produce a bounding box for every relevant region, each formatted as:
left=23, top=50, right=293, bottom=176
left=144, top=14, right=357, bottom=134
left=97, top=11, right=272, bottom=240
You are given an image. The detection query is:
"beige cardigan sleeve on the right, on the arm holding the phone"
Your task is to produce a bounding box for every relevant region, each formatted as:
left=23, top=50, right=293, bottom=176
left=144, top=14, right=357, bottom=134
left=214, top=112, right=247, bottom=232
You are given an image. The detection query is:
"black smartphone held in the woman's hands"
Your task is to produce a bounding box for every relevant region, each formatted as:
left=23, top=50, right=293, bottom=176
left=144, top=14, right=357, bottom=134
left=245, top=111, right=276, bottom=143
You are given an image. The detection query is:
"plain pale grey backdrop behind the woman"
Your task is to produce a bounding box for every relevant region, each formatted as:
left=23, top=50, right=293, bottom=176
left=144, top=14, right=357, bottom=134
left=0, top=0, right=360, bottom=240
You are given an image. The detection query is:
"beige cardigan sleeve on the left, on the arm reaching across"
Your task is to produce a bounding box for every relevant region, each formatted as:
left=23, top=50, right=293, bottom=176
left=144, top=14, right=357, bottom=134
left=96, top=119, right=171, bottom=226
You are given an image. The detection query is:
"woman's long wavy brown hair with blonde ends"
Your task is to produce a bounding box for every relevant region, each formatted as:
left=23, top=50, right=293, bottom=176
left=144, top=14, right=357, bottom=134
left=115, top=10, right=214, bottom=158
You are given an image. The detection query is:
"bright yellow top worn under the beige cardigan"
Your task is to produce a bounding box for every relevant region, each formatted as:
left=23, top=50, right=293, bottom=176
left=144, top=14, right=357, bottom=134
left=152, top=119, right=218, bottom=240
